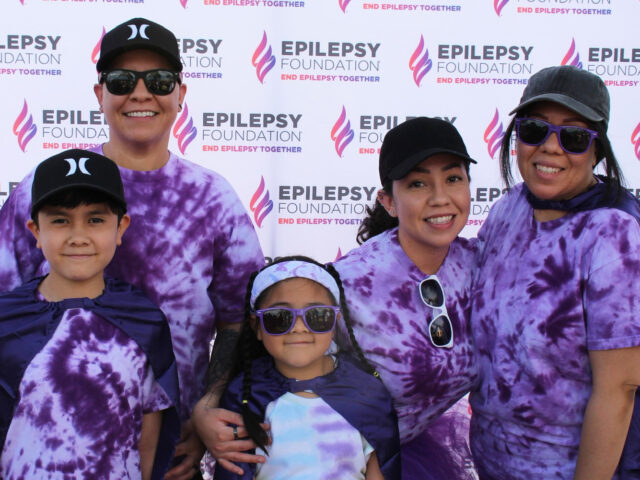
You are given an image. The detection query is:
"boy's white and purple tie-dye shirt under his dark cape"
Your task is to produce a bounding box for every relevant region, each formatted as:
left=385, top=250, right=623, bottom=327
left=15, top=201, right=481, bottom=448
left=0, top=309, right=171, bottom=480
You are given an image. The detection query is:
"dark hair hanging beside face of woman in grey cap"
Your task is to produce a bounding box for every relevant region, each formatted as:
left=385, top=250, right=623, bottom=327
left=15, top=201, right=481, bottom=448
left=500, top=109, right=625, bottom=197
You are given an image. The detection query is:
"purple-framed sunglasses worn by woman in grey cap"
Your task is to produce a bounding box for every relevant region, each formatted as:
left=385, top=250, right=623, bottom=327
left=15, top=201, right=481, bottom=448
left=516, top=118, right=598, bottom=154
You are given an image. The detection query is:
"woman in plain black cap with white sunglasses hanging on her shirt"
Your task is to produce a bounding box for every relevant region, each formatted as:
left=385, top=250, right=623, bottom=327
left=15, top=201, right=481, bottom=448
left=335, top=117, right=476, bottom=479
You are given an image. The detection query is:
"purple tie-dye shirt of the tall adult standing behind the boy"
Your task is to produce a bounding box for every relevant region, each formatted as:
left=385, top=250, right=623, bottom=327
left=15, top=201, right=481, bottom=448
left=0, top=148, right=264, bottom=420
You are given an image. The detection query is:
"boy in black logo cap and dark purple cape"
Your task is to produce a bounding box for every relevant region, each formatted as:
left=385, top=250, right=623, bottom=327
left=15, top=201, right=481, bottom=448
left=0, top=150, right=180, bottom=480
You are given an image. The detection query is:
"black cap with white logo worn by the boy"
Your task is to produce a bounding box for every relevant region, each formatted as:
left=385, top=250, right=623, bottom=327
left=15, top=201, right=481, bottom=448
left=31, top=149, right=127, bottom=217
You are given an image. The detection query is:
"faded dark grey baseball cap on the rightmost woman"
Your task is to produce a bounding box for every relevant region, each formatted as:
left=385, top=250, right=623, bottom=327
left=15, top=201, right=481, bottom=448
left=510, top=65, right=610, bottom=126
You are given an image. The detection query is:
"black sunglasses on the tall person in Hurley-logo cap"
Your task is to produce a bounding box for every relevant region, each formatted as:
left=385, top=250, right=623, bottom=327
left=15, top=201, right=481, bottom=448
left=99, top=68, right=180, bottom=95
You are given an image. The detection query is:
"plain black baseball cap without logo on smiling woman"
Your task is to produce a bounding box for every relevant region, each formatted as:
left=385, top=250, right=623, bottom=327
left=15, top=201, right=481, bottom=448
left=379, top=117, right=477, bottom=185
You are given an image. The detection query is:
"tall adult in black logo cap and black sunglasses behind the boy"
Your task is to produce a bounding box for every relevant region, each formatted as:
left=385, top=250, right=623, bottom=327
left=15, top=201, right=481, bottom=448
left=0, top=18, right=264, bottom=480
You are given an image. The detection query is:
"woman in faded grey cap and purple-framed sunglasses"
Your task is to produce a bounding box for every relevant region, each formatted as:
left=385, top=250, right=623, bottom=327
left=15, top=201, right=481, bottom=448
left=471, top=66, right=640, bottom=480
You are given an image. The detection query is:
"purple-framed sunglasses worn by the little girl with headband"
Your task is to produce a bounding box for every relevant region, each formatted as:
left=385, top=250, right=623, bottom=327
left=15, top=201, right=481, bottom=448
left=256, top=305, right=340, bottom=335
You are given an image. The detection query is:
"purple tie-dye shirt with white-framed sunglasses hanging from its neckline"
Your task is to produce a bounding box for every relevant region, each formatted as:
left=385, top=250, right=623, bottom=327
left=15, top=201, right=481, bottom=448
left=334, top=228, right=476, bottom=478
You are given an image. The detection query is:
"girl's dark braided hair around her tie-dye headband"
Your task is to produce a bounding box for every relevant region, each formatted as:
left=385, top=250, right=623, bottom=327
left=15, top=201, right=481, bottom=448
left=230, top=255, right=380, bottom=452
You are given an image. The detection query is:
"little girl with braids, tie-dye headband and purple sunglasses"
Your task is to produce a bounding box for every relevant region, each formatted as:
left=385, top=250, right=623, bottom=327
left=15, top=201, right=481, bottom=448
left=215, top=257, right=401, bottom=480
